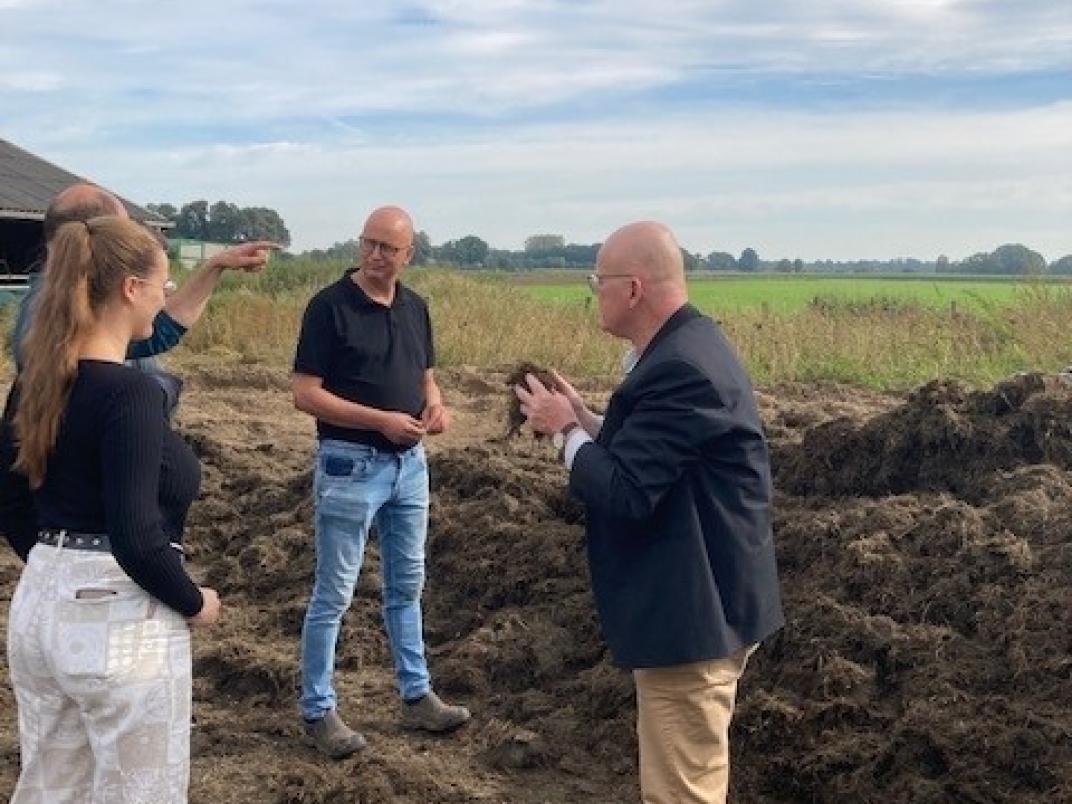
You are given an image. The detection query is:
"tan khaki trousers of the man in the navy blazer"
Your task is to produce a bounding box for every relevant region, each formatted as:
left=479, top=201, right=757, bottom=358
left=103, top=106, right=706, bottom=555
left=632, top=645, right=756, bottom=804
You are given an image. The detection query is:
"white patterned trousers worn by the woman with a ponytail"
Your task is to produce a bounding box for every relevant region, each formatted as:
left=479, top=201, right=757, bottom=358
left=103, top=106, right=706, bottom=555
left=8, top=545, right=192, bottom=804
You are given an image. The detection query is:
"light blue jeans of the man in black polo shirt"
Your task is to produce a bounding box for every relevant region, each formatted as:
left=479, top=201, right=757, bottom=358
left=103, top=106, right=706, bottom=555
left=301, top=438, right=431, bottom=719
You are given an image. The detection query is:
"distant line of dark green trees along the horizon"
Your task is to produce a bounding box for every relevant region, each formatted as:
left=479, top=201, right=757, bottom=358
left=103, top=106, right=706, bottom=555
left=148, top=200, right=1072, bottom=276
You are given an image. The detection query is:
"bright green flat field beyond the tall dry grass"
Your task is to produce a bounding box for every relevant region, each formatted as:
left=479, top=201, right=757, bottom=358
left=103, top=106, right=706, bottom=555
left=523, top=273, right=1072, bottom=314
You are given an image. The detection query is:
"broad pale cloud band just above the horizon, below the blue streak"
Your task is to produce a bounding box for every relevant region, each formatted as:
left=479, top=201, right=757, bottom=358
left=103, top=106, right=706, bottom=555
left=27, top=104, right=1072, bottom=258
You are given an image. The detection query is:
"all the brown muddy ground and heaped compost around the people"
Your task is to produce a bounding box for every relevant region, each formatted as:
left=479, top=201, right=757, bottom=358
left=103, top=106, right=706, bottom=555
left=0, top=367, right=1072, bottom=804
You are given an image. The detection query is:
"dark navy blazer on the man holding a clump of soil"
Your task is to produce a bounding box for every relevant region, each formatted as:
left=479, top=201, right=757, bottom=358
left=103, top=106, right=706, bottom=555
left=569, top=304, right=785, bottom=668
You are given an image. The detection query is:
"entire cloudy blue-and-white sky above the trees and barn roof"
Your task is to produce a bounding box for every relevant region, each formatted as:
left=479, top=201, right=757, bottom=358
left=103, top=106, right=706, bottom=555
left=0, top=0, right=1072, bottom=259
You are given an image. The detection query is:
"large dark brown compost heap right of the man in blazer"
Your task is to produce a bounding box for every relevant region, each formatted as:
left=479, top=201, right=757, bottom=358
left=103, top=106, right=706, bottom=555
left=736, top=375, right=1072, bottom=802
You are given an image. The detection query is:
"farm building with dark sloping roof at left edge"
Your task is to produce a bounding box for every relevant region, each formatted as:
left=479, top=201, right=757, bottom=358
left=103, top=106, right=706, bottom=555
left=0, top=139, right=173, bottom=285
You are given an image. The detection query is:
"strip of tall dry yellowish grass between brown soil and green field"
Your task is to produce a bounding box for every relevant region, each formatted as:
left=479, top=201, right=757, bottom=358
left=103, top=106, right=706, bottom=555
left=0, top=265, right=1072, bottom=390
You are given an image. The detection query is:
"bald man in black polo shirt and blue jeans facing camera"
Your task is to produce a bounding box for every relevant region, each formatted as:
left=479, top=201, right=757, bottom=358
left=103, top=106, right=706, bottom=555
left=293, top=207, right=470, bottom=758
